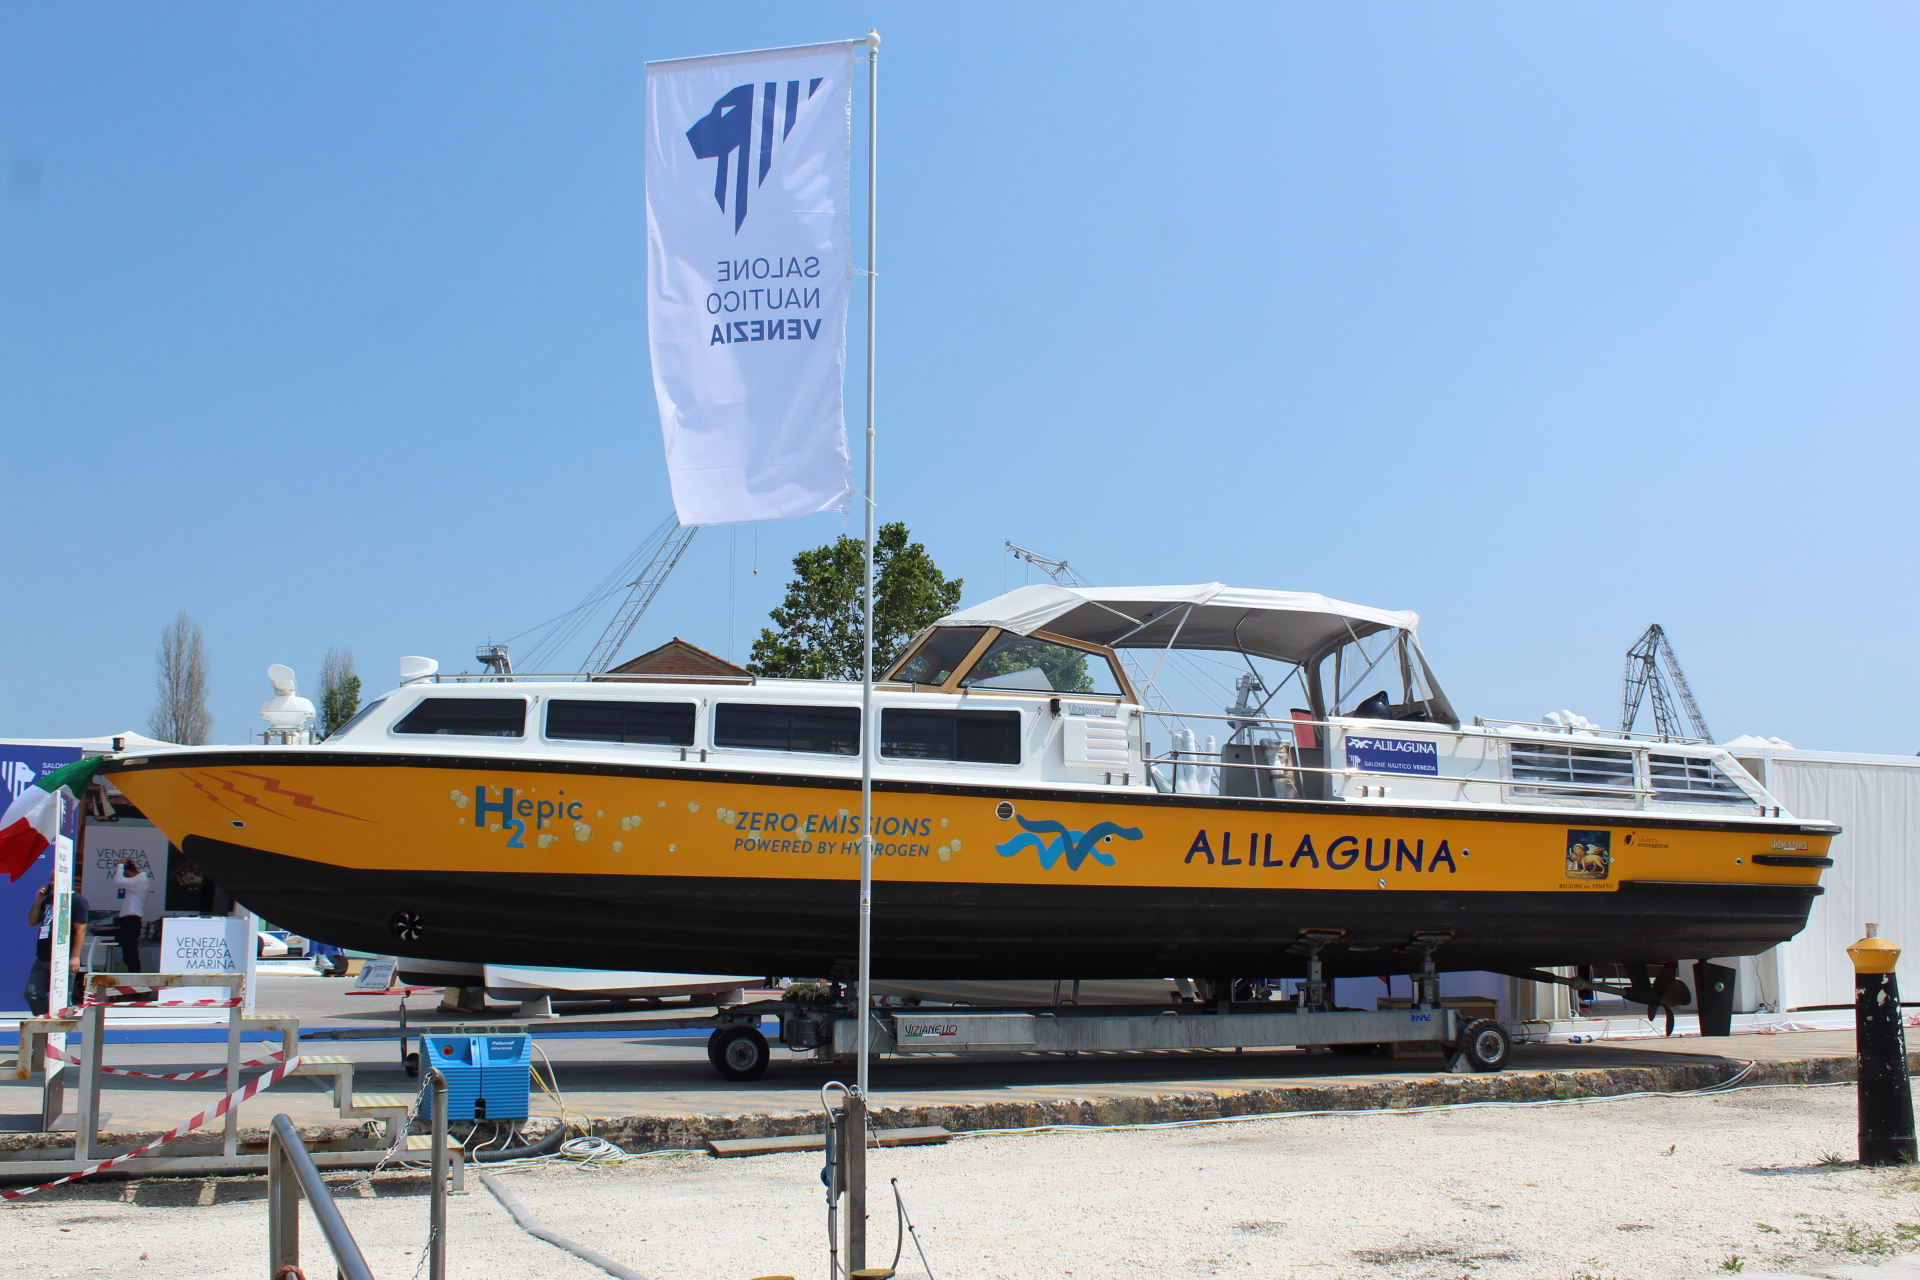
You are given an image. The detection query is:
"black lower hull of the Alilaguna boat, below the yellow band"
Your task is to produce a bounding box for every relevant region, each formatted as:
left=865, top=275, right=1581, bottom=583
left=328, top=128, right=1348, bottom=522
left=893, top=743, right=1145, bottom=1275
left=184, top=837, right=1820, bottom=981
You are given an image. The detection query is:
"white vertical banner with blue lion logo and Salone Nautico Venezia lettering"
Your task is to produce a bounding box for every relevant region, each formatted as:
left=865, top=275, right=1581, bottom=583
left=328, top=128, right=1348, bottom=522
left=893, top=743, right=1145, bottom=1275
left=647, top=40, right=852, bottom=526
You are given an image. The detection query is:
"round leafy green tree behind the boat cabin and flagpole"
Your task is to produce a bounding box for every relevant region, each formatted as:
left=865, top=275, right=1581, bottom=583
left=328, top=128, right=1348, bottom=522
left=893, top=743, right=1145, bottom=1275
left=747, top=522, right=962, bottom=679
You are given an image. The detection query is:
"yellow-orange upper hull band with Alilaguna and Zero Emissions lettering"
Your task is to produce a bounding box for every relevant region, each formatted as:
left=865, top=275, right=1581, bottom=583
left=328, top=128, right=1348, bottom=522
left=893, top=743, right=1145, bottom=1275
left=113, top=760, right=1832, bottom=892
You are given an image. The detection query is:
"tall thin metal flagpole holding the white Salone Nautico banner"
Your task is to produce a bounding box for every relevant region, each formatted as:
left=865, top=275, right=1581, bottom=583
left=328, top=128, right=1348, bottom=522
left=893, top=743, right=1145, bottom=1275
left=847, top=31, right=879, bottom=1270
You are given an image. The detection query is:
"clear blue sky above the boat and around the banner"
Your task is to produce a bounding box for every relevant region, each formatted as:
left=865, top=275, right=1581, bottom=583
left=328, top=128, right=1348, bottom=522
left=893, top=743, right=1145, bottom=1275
left=0, top=2, right=1920, bottom=752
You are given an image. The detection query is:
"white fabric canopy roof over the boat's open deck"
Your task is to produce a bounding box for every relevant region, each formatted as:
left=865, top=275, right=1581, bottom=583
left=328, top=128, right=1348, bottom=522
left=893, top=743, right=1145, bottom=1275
left=935, top=581, right=1421, bottom=664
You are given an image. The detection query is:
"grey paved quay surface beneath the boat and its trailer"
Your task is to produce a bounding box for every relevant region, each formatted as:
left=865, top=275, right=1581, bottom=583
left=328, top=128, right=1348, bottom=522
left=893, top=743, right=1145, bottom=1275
left=0, top=977, right=1853, bottom=1130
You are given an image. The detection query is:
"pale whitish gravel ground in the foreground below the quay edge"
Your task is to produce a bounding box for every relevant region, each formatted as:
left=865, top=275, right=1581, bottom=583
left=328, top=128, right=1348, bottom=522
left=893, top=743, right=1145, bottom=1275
left=0, top=1088, right=1920, bottom=1280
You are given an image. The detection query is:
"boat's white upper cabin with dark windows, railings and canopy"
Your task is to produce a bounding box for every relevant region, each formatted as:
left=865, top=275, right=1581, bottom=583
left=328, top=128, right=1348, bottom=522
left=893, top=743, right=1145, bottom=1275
left=321, top=583, right=1789, bottom=818
